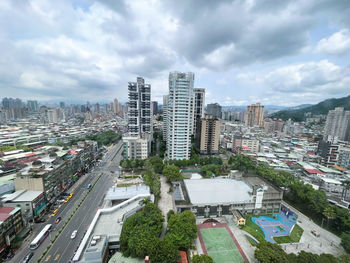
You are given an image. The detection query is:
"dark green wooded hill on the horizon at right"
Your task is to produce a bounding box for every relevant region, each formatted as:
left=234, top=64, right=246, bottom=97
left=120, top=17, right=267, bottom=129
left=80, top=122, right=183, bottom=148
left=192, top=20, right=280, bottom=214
left=270, top=95, right=350, bottom=121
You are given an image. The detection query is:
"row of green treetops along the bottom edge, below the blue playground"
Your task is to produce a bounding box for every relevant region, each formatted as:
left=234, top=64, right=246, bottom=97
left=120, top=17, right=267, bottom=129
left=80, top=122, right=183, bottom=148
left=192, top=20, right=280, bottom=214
left=255, top=242, right=350, bottom=263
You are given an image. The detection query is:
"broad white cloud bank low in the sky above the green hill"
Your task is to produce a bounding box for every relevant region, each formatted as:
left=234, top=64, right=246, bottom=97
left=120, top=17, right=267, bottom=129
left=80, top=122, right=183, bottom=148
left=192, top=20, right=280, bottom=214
left=237, top=60, right=350, bottom=105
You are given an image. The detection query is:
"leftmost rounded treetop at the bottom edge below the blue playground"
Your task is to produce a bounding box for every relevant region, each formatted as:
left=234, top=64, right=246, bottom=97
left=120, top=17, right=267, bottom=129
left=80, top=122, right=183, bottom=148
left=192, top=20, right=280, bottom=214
left=254, top=242, right=289, bottom=263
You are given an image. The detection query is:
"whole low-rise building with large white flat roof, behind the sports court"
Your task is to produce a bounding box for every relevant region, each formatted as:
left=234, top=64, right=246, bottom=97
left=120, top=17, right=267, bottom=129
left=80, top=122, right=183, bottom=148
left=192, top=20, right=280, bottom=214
left=174, top=176, right=283, bottom=217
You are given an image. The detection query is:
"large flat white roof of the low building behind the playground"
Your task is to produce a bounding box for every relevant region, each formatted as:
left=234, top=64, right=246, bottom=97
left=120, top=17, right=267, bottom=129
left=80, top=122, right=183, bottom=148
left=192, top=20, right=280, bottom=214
left=184, top=178, right=253, bottom=205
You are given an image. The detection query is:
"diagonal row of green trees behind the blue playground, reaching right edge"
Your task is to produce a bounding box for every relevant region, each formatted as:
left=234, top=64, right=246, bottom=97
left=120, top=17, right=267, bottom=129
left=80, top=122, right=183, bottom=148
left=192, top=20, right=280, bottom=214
left=229, top=155, right=350, bottom=253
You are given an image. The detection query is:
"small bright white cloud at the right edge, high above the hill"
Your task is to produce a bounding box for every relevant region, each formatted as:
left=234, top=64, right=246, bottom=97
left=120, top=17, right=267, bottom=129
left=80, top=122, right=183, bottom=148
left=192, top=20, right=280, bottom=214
left=316, top=29, right=350, bottom=55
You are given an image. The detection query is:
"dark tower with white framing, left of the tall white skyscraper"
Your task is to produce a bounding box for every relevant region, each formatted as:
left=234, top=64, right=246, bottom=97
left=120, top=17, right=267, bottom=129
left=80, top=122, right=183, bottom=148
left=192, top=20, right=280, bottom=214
left=128, top=77, right=152, bottom=137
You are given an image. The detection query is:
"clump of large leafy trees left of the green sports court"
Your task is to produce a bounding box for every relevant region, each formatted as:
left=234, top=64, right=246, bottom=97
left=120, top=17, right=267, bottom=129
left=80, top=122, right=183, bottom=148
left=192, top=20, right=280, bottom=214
left=120, top=201, right=197, bottom=263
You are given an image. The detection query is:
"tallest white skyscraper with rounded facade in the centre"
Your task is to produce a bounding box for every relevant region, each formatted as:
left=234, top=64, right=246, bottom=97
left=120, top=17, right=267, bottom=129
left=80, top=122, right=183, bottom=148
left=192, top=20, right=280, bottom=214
left=166, top=72, right=194, bottom=160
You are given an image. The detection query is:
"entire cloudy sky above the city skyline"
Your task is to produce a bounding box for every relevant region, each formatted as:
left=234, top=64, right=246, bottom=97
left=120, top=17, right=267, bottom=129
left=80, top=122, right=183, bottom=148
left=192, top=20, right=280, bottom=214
left=0, top=0, right=350, bottom=106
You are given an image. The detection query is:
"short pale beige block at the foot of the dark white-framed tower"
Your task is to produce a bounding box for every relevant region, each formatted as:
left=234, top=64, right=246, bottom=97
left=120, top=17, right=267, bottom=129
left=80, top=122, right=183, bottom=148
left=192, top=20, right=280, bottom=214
left=123, top=137, right=148, bottom=159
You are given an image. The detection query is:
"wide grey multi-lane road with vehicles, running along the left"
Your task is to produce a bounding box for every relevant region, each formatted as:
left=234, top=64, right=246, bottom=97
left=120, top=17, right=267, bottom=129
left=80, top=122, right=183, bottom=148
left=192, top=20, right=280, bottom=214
left=11, top=141, right=122, bottom=263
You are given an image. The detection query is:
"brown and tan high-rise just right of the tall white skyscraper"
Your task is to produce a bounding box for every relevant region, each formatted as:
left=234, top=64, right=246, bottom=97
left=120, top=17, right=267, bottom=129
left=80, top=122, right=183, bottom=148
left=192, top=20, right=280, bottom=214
left=198, top=115, right=220, bottom=154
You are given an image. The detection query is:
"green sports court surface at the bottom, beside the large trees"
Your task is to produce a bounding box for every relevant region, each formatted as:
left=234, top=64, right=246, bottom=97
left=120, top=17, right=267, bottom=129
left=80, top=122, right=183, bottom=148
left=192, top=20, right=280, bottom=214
left=200, top=227, right=244, bottom=263
